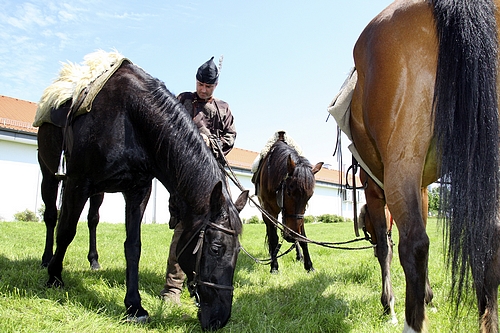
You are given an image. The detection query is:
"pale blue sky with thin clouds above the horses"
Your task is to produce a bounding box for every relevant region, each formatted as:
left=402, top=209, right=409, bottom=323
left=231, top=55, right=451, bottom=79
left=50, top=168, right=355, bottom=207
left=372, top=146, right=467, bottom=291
left=0, top=0, right=392, bottom=169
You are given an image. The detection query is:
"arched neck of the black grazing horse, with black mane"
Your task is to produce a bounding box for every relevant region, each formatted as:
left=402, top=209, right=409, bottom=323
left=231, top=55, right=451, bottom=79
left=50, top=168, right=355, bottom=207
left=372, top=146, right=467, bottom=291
left=120, top=67, right=222, bottom=212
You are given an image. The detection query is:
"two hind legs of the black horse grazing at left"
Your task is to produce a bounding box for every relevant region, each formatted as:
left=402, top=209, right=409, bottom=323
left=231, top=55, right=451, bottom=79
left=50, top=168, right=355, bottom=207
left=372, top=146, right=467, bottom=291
left=37, top=100, right=104, bottom=270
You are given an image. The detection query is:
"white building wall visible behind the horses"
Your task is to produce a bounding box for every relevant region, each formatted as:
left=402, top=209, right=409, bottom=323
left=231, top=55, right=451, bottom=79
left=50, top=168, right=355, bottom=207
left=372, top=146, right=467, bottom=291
left=0, top=132, right=364, bottom=223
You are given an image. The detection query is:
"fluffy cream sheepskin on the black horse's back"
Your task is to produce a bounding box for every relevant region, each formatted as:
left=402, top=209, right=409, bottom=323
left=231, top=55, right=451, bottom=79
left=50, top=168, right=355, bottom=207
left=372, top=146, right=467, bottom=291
left=33, top=50, right=130, bottom=127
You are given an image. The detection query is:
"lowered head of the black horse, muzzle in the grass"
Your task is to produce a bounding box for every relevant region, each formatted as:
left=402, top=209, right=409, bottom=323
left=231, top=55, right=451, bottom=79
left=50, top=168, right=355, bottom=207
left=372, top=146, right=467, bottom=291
left=177, top=182, right=248, bottom=330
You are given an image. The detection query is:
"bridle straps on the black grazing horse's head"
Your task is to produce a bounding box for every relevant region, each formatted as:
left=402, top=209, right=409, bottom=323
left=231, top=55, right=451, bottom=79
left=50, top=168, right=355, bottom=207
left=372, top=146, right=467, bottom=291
left=177, top=215, right=238, bottom=307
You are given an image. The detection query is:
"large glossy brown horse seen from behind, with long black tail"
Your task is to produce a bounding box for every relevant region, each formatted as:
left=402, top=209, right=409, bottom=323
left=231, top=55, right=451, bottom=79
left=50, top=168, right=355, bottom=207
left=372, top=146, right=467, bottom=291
left=350, top=0, right=500, bottom=332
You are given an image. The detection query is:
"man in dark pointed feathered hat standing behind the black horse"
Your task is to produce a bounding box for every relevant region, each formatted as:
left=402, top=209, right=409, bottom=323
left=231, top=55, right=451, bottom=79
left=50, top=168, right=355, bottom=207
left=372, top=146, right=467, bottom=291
left=160, top=57, right=236, bottom=304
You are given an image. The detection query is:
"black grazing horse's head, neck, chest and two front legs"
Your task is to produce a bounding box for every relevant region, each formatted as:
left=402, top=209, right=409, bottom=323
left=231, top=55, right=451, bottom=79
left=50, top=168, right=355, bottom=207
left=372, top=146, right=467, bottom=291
left=35, top=52, right=248, bottom=329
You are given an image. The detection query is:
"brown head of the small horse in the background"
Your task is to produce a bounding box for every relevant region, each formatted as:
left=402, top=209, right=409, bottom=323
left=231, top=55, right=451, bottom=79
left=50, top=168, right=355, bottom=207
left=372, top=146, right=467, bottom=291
left=278, top=155, right=323, bottom=242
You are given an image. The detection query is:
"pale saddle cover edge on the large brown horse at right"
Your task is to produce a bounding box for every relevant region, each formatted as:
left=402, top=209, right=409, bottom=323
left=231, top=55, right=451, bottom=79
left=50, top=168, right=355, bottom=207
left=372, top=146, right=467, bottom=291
left=328, top=68, right=384, bottom=189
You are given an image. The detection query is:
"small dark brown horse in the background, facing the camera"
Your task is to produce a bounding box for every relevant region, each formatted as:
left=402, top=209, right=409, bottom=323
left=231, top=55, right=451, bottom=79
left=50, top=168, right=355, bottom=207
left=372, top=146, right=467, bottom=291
left=258, top=133, right=323, bottom=273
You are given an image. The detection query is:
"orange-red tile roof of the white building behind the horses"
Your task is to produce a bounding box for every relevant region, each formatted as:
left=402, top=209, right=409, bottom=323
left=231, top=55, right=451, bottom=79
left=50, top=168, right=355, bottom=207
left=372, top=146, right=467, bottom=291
left=0, top=95, right=359, bottom=184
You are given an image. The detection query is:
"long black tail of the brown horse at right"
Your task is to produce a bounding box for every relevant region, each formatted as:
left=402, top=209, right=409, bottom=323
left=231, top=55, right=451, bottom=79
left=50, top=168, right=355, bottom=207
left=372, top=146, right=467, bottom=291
left=432, top=0, right=499, bottom=304
